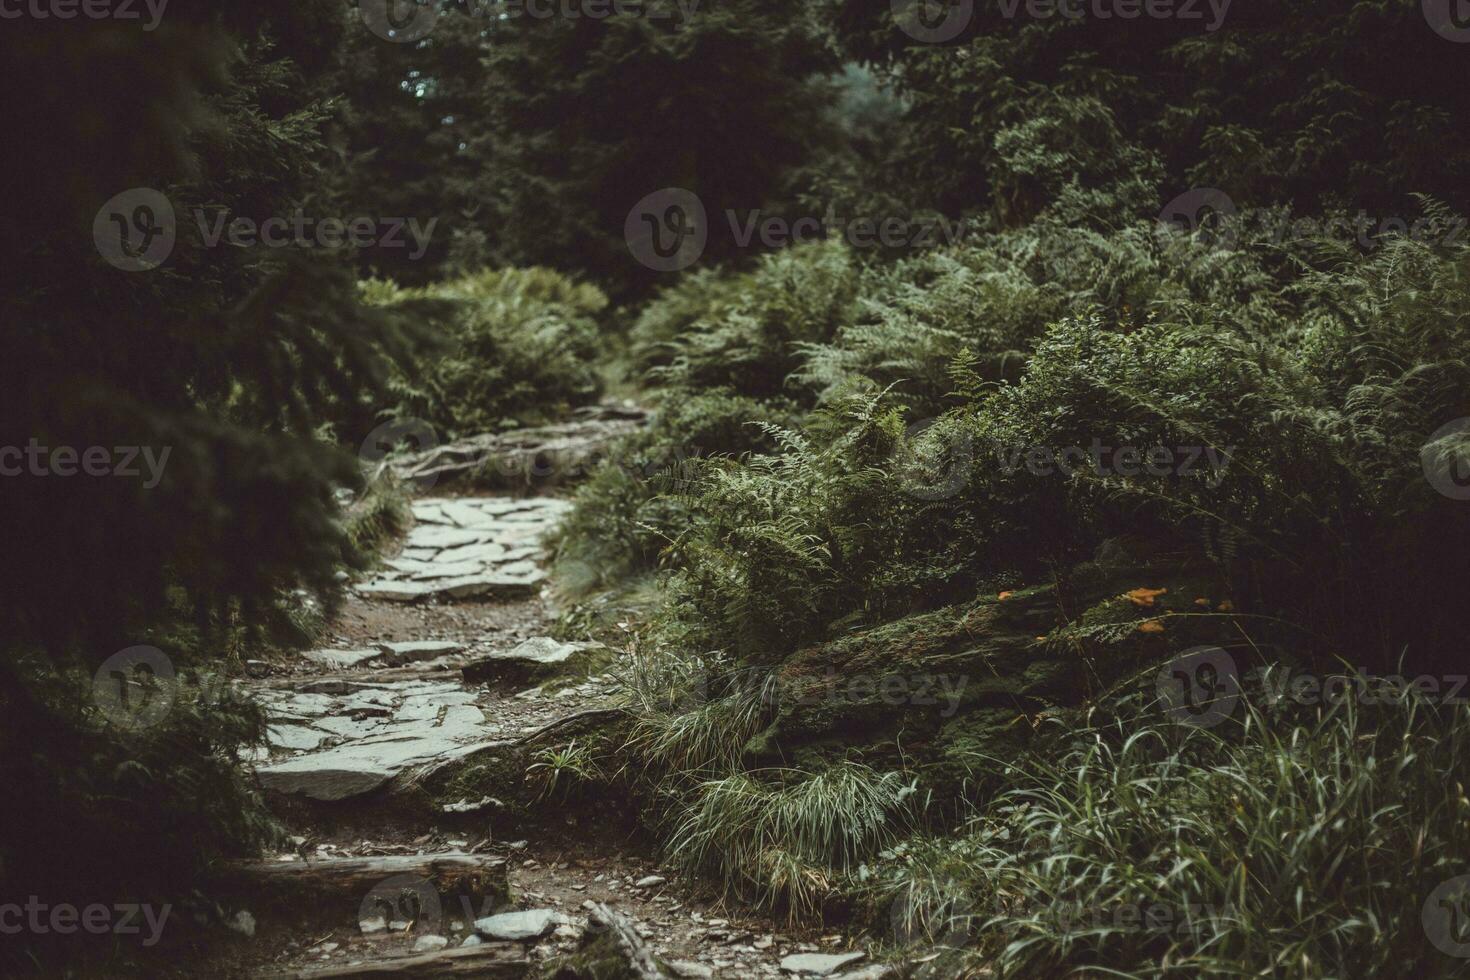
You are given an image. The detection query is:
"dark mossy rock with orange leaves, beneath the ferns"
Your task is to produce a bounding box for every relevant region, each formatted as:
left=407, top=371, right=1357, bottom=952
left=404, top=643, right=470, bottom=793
left=745, top=566, right=1235, bottom=783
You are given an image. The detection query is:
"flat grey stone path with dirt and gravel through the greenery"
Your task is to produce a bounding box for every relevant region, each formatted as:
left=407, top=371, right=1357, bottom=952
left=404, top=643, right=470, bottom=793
left=229, top=497, right=886, bottom=980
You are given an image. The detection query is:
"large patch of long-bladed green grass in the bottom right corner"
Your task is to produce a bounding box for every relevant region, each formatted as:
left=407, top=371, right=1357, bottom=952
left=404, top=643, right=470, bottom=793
left=875, top=688, right=1470, bottom=977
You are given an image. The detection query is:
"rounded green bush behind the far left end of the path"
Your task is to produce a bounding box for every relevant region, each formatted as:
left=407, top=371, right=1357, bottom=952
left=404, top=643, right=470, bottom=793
left=363, top=269, right=607, bottom=433
